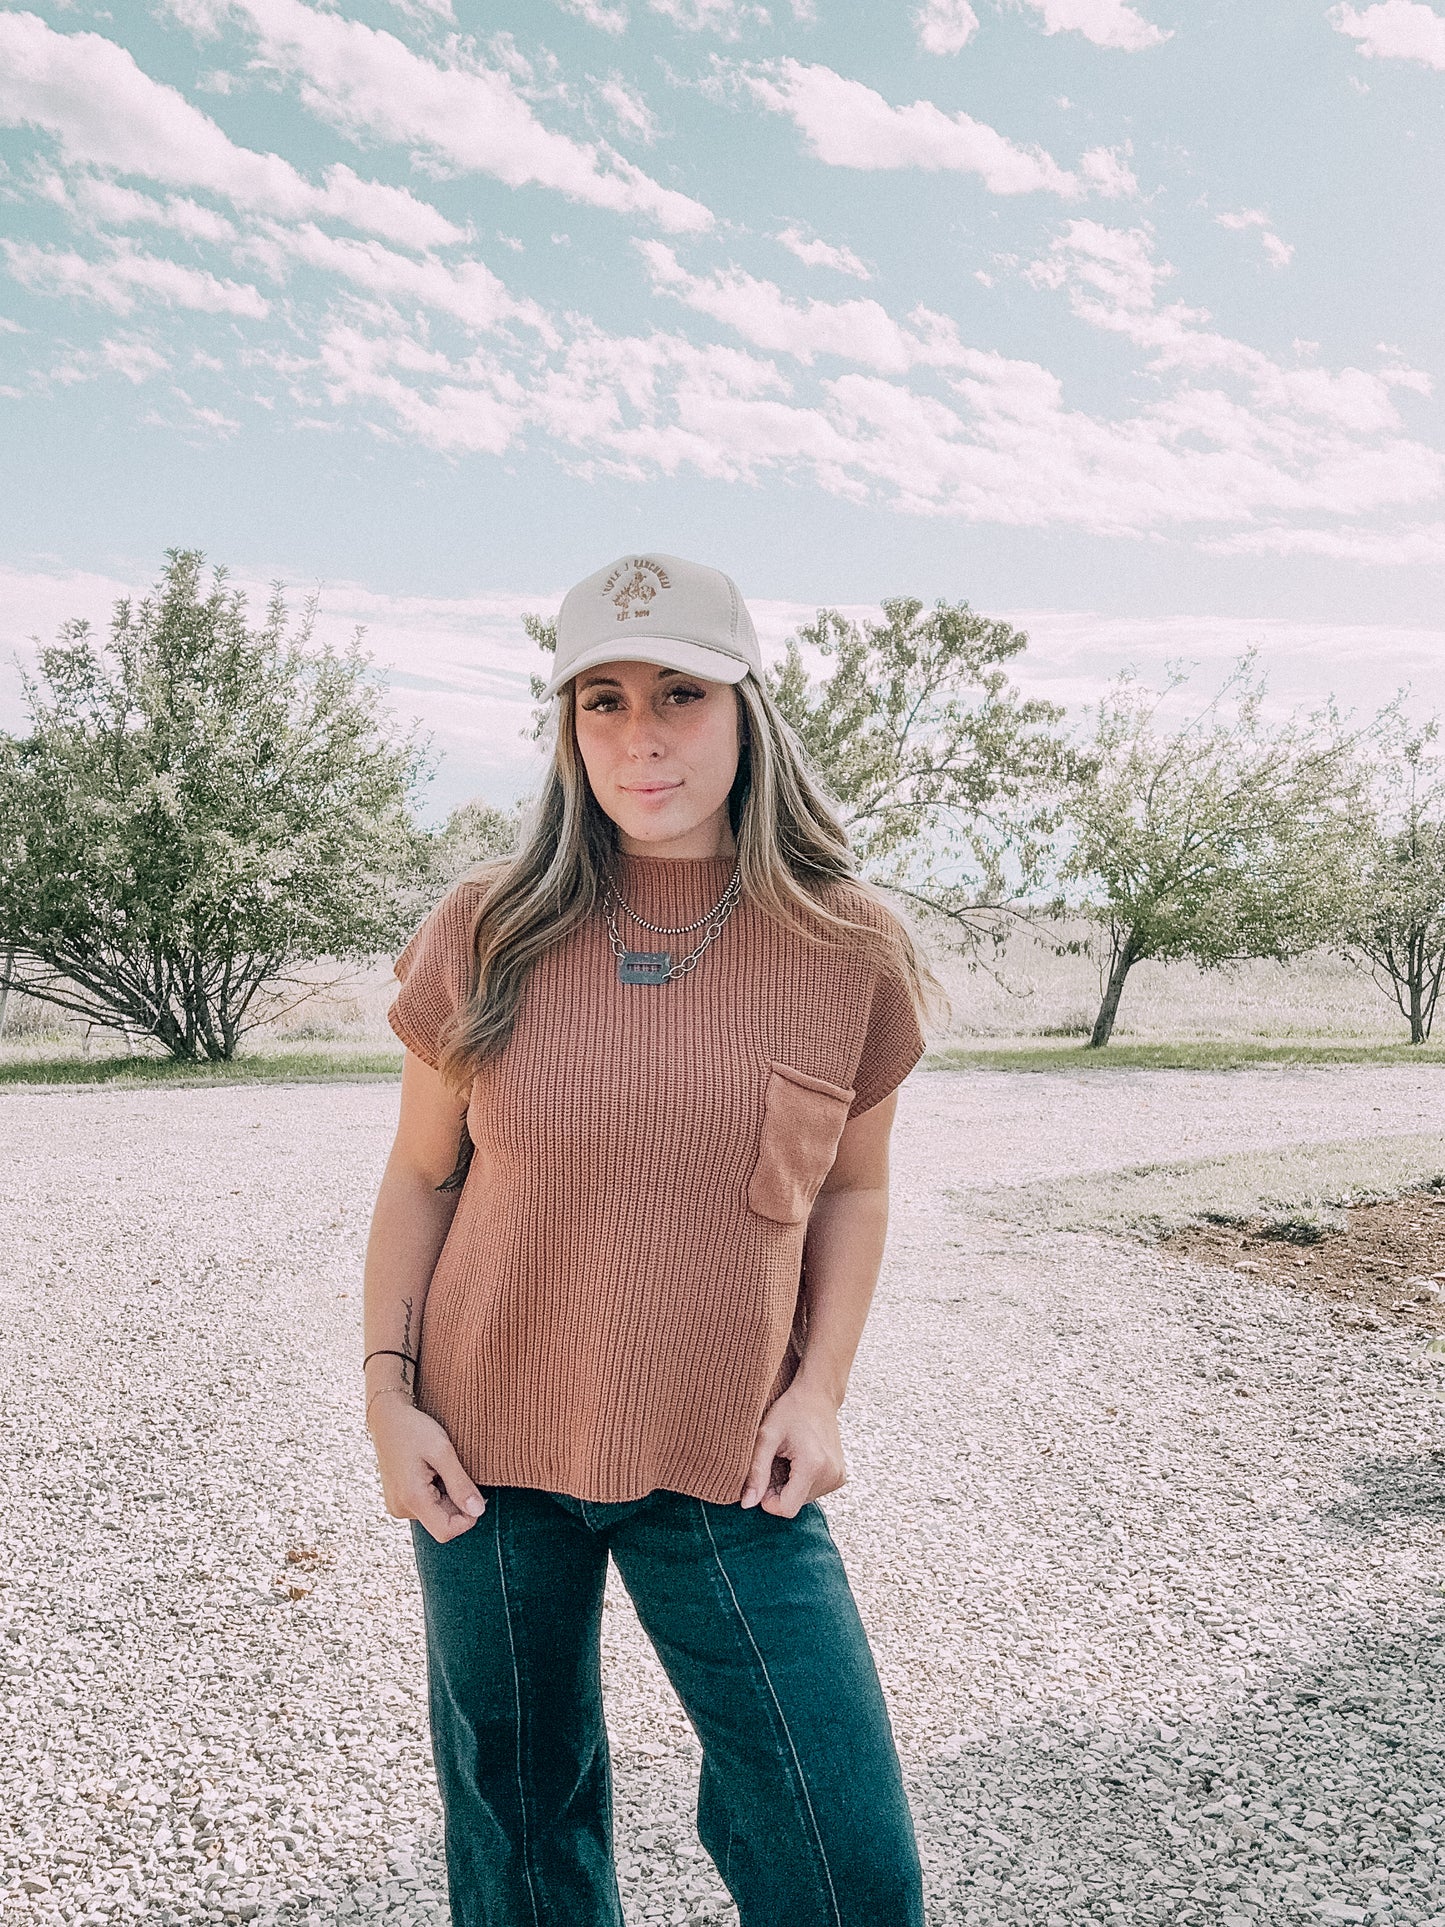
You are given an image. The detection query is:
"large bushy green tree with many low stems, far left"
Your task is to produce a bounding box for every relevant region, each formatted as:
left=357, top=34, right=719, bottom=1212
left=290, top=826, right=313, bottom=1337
left=0, top=549, right=435, bottom=1060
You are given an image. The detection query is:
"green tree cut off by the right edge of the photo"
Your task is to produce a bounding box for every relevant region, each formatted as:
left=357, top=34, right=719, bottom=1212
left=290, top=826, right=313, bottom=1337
left=1345, top=713, right=1445, bottom=1044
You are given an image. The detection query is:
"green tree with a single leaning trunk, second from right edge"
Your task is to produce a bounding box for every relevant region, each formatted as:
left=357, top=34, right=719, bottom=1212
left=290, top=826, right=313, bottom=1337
left=1064, top=651, right=1364, bottom=1048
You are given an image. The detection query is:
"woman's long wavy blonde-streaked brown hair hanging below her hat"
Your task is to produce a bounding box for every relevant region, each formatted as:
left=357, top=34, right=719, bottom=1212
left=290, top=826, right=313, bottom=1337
left=439, top=674, right=938, bottom=1091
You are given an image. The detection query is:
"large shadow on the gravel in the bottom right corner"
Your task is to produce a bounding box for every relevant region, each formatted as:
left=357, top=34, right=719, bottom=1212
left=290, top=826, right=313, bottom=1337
left=909, top=1601, right=1445, bottom=1927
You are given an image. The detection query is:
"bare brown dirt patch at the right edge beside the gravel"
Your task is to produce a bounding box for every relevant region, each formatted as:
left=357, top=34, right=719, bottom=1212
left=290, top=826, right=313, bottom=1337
left=1160, top=1189, right=1445, bottom=1332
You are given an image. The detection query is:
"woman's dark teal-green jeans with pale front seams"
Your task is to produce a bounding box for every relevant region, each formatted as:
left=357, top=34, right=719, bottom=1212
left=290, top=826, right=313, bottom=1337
left=412, top=1486, right=923, bottom=1927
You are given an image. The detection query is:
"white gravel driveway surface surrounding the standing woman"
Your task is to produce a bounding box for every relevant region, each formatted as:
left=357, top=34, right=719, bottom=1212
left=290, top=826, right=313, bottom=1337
left=0, top=1069, right=1445, bottom=1927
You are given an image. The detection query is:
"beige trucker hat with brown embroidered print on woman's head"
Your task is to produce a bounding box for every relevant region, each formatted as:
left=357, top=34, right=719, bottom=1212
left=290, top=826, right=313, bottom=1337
left=547, top=551, right=763, bottom=696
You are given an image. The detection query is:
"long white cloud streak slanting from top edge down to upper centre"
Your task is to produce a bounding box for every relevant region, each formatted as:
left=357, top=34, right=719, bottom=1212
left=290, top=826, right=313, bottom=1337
left=204, top=0, right=713, bottom=233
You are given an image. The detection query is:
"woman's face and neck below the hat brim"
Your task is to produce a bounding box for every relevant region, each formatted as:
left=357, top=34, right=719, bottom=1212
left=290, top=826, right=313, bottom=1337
left=576, top=663, right=738, bottom=858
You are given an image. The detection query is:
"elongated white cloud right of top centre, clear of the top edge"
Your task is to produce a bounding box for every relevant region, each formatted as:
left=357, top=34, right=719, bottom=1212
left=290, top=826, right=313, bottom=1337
left=740, top=60, right=1081, bottom=198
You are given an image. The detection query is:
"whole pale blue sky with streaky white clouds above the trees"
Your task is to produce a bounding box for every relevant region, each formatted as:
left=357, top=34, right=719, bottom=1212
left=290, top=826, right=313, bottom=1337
left=0, top=0, right=1445, bottom=802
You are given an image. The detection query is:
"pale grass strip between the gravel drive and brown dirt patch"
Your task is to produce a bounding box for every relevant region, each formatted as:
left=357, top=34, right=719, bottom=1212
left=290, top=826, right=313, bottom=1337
left=948, top=1131, right=1445, bottom=1237
